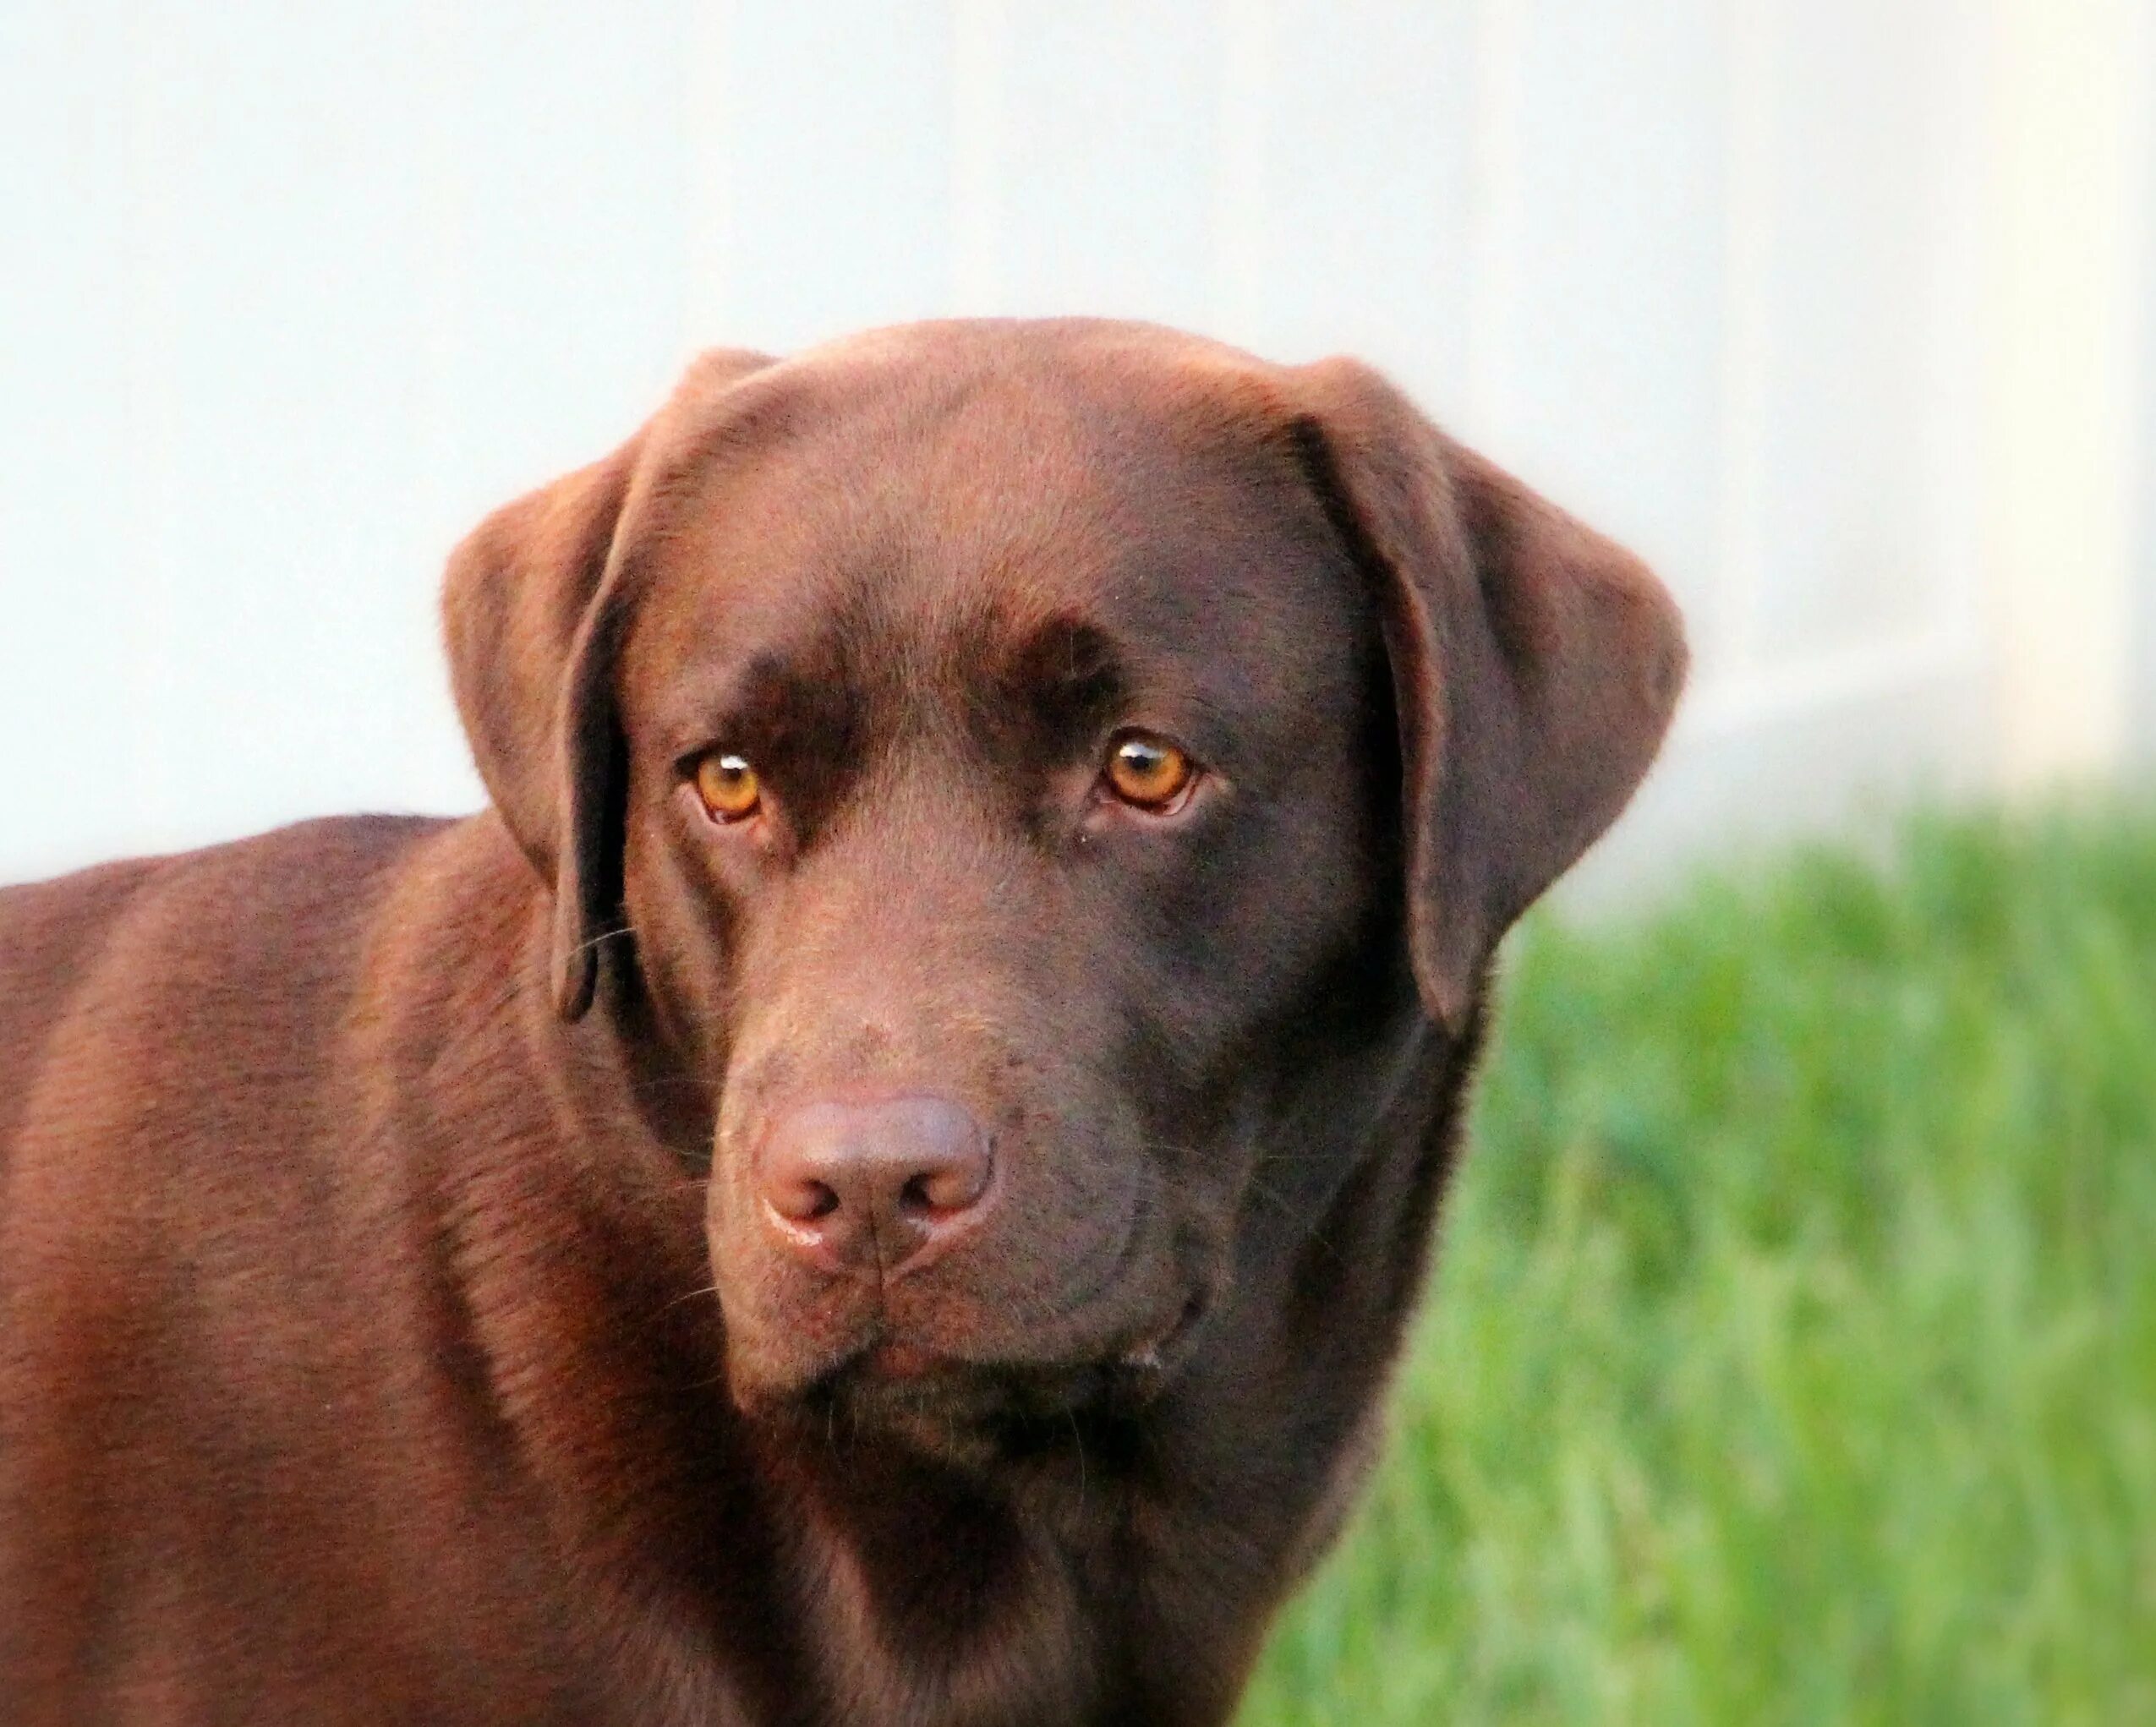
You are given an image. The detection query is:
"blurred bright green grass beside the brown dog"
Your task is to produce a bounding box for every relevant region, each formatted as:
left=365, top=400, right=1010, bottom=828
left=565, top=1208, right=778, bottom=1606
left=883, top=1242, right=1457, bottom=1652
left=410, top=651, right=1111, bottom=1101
left=1242, top=811, right=2156, bottom=1727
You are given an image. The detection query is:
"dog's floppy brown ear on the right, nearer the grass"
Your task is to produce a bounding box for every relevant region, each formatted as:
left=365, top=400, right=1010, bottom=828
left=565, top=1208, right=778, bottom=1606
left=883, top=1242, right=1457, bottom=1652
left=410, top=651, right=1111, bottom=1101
left=1294, top=349, right=1686, bottom=1030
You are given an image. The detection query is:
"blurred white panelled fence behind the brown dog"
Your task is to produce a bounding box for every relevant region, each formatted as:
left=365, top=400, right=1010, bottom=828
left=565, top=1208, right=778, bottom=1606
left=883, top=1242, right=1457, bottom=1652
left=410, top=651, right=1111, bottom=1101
left=0, top=0, right=2156, bottom=880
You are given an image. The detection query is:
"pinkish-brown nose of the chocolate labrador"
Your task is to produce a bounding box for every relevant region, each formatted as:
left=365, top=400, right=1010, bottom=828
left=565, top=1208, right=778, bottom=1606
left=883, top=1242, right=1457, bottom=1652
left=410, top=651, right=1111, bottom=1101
left=757, top=1096, right=994, bottom=1276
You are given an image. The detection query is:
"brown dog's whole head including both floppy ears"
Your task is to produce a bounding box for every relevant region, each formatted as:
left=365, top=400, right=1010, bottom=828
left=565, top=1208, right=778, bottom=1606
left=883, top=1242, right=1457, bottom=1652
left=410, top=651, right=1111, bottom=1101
left=448, top=324, right=1682, bottom=1432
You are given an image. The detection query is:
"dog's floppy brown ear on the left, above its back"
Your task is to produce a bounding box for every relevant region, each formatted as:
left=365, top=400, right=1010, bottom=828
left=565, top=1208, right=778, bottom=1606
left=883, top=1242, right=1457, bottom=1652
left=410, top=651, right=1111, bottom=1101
left=442, top=349, right=769, bottom=1019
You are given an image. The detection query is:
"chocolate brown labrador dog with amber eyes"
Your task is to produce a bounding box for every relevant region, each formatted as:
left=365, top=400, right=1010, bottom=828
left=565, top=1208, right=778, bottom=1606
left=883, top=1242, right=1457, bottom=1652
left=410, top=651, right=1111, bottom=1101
left=0, top=321, right=1684, bottom=1727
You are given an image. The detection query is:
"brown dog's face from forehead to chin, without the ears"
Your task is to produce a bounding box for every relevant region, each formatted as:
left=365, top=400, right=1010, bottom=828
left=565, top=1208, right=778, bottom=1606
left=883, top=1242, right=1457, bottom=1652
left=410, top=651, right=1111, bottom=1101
left=616, top=340, right=1399, bottom=1431
